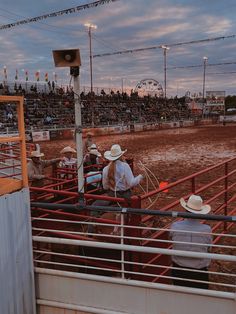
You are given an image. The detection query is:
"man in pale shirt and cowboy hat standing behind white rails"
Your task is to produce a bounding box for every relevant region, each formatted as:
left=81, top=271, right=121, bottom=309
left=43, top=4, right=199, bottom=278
left=170, top=195, right=212, bottom=289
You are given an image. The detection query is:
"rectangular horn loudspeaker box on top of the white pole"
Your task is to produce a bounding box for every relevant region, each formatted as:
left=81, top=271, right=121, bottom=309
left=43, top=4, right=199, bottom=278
left=52, top=49, right=81, bottom=67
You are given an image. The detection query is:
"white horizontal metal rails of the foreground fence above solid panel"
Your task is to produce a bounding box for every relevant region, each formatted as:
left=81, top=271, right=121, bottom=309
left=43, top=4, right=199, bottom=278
left=32, top=206, right=236, bottom=293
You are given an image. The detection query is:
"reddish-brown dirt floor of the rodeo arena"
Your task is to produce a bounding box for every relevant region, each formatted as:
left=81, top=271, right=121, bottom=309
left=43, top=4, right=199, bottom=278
left=40, top=125, right=236, bottom=183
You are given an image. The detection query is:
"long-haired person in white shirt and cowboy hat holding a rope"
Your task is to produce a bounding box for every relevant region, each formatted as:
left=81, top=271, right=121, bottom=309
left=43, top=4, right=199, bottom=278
left=102, top=144, right=143, bottom=198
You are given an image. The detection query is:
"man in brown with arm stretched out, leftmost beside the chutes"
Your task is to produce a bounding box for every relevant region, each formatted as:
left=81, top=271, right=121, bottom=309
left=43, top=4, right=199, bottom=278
left=27, top=151, right=61, bottom=187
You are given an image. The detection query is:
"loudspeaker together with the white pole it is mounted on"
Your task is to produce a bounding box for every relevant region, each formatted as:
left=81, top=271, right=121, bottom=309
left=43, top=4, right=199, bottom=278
left=52, top=49, right=84, bottom=194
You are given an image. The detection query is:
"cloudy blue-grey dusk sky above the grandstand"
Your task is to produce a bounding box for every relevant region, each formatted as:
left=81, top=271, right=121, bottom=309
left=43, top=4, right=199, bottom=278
left=0, top=0, right=236, bottom=97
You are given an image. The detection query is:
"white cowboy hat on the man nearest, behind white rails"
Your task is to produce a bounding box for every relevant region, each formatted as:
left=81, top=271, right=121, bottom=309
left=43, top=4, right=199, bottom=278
left=180, top=195, right=211, bottom=214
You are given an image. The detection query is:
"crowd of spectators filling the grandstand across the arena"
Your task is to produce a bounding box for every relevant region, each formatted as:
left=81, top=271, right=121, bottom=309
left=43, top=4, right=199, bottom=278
left=0, top=82, right=194, bottom=130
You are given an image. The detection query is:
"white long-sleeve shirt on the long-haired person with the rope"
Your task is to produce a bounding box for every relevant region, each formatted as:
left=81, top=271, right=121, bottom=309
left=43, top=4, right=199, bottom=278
left=102, top=160, right=143, bottom=191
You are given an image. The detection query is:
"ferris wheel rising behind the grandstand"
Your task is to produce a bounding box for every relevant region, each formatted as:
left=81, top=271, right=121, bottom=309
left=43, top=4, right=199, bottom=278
left=135, top=79, right=164, bottom=97
